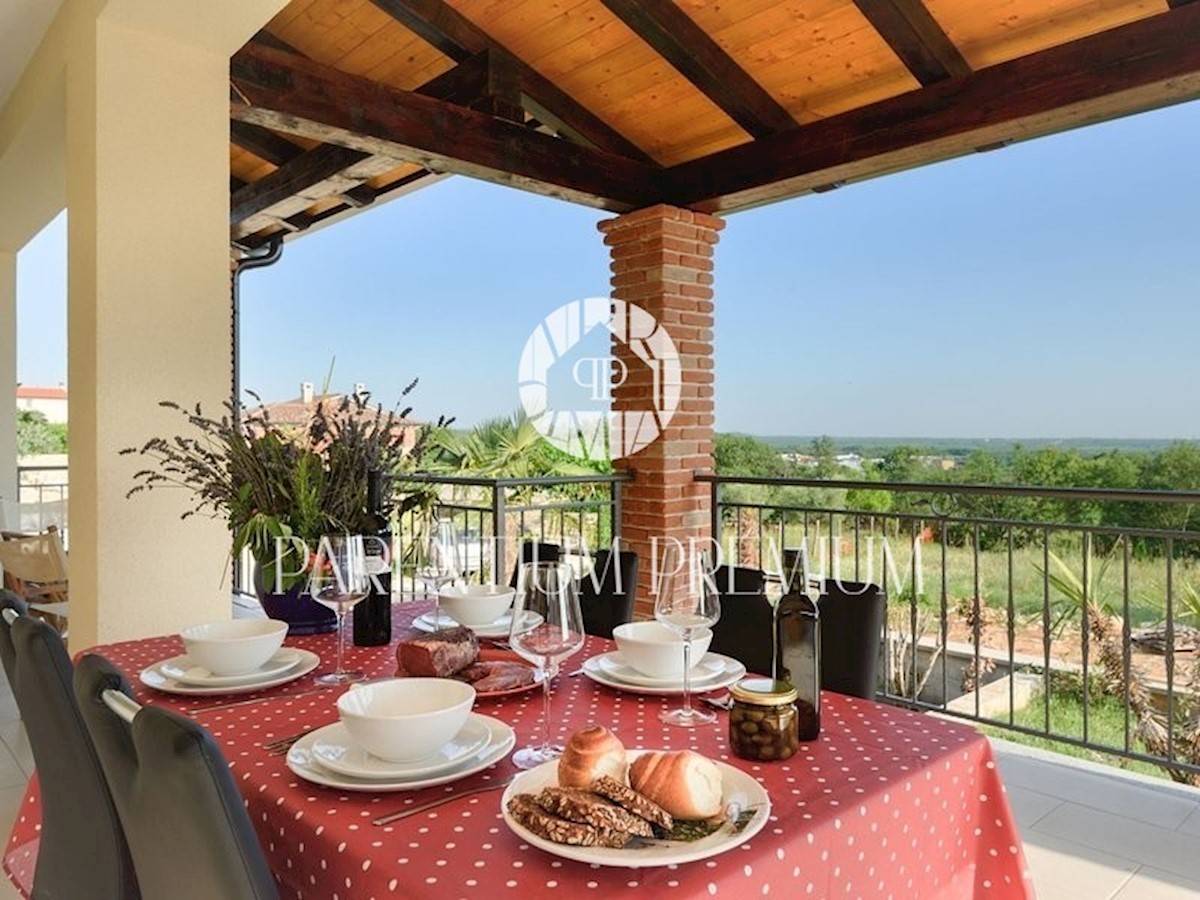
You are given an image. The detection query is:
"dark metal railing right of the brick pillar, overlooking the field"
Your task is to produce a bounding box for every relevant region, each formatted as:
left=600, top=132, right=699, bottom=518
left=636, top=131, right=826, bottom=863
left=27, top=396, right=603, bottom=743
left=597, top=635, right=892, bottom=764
left=697, top=475, right=1200, bottom=784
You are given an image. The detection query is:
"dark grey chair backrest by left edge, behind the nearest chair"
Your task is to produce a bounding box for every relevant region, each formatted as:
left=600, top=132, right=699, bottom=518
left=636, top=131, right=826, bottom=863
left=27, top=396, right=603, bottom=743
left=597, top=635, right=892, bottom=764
left=0, top=609, right=139, bottom=900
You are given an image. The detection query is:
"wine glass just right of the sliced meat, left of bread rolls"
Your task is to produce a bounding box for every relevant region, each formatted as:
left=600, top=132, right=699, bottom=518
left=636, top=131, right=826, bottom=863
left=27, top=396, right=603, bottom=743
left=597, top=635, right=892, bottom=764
left=509, top=563, right=584, bottom=769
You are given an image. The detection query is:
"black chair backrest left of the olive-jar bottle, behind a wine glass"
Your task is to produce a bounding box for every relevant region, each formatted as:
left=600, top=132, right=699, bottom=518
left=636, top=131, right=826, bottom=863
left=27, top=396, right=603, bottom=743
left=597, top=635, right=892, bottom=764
left=708, top=565, right=775, bottom=676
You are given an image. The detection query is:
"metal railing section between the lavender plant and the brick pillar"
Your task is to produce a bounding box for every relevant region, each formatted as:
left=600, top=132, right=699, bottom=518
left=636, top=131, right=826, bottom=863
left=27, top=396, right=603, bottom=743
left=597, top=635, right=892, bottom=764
left=396, top=474, right=629, bottom=592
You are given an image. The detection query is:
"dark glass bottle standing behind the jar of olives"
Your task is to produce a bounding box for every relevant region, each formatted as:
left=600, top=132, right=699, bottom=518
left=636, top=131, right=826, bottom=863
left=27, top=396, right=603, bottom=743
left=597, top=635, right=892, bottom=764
left=775, top=551, right=821, bottom=740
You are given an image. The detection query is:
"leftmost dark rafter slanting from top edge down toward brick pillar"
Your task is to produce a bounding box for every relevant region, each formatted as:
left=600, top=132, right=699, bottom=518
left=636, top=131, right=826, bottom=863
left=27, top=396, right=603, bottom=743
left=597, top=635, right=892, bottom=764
left=371, top=0, right=652, bottom=163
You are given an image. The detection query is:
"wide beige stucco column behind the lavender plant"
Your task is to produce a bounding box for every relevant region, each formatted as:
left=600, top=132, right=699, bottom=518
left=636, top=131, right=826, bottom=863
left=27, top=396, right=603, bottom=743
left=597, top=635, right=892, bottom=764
left=66, top=0, right=283, bottom=649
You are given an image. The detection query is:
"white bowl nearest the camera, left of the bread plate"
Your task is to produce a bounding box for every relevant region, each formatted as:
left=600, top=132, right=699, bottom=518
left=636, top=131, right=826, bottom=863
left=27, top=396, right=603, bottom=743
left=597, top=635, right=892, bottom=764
left=337, top=678, right=475, bottom=762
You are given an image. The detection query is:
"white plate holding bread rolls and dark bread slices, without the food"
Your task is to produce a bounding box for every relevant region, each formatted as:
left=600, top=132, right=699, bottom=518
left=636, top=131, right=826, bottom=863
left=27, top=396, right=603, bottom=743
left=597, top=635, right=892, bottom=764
left=500, top=750, right=770, bottom=869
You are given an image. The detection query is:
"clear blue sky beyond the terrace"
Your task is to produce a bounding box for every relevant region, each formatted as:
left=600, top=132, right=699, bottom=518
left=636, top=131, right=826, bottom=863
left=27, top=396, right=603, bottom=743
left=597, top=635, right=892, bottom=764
left=11, top=103, right=1200, bottom=438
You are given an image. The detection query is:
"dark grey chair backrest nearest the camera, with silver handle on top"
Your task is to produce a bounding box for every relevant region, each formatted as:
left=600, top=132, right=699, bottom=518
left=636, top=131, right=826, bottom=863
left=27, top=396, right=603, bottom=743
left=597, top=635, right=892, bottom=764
left=74, top=655, right=278, bottom=900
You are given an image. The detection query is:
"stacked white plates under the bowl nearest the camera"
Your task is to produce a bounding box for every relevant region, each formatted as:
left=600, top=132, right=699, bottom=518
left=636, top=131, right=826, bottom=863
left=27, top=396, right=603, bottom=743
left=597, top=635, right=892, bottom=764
left=288, top=713, right=516, bottom=791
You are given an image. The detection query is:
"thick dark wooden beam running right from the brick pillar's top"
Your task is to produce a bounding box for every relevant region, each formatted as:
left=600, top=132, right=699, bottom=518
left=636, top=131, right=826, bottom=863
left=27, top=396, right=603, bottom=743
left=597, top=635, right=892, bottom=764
left=667, top=4, right=1200, bottom=211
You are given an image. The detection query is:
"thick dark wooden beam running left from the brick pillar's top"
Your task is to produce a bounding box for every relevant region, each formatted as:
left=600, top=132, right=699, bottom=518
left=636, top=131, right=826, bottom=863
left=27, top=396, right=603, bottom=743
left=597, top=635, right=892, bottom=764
left=230, top=46, right=661, bottom=211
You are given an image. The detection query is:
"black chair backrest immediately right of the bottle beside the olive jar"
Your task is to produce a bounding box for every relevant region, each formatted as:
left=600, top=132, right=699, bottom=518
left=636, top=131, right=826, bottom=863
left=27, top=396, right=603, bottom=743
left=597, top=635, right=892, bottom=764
left=817, top=578, right=887, bottom=700
